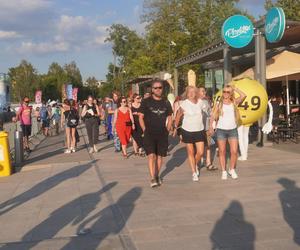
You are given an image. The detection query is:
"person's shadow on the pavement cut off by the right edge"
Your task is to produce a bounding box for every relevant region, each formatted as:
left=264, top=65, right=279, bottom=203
left=277, top=178, right=300, bottom=246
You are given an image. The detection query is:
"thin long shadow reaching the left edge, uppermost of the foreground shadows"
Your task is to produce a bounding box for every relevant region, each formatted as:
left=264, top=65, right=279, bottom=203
left=0, top=161, right=95, bottom=216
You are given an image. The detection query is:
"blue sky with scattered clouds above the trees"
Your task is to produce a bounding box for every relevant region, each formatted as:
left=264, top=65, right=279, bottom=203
left=0, top=0, right=264, bottom=79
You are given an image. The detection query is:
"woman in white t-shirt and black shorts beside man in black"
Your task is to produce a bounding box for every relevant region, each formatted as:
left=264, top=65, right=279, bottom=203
left=175, top=86, right=206, bottom=181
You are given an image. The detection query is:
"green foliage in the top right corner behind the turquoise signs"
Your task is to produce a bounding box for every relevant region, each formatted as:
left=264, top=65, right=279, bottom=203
left=265, top=0, right=300, bottom=21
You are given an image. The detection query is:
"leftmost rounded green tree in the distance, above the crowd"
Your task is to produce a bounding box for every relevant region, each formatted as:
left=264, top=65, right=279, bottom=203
left=8, top=60, right=39, bottom=101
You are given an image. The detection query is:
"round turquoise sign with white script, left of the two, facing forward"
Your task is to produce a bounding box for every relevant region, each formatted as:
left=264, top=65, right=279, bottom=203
left=222, top=15, right=254, bottom=48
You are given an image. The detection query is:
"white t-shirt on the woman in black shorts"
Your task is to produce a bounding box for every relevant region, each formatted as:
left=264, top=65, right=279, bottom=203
left=180, top=99, right=206, bottom=132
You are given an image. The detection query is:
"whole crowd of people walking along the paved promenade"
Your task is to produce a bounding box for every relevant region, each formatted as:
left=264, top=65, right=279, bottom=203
left=15, top=80, right=246, bottom=187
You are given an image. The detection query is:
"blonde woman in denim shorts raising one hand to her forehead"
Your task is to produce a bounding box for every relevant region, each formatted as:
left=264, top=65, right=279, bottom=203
left=210, top=85, right=246, bottom=180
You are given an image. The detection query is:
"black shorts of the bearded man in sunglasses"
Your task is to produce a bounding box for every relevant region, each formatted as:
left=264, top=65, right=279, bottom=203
left=144, top=131, right=169, bottom=157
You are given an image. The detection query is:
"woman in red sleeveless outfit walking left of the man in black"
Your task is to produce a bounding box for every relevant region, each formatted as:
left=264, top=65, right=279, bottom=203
left=113, top=97, right=135, bottom=158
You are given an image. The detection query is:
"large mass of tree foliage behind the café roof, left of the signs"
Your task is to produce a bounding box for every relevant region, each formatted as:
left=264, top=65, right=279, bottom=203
left=107, top=0, right=248, bottom=90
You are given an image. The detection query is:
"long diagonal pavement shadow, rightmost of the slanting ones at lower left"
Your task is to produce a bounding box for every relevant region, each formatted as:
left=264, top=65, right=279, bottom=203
left=61, top=187, right=142, bottom=250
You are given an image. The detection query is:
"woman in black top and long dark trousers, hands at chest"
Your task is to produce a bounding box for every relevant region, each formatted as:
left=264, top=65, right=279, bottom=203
left=81, top=96, right=100, bottom=154
